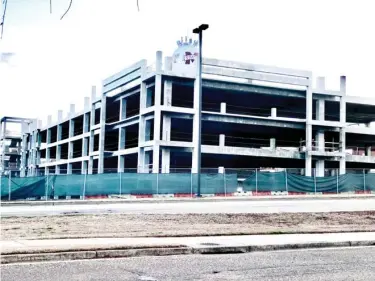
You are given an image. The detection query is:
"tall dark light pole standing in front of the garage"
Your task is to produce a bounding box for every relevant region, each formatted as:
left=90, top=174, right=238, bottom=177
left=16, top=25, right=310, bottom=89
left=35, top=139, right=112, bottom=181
left=193, top=24, right=208, bottom=197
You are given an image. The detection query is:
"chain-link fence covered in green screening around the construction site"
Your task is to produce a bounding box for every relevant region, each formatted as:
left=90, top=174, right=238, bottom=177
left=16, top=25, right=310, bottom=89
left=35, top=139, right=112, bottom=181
left=0, top=168, right=375, bottom=200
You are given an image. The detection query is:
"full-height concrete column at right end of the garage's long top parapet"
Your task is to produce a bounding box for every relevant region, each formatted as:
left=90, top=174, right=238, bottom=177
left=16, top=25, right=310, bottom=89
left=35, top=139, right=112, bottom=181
left=305, top=81, right=313, bottom=177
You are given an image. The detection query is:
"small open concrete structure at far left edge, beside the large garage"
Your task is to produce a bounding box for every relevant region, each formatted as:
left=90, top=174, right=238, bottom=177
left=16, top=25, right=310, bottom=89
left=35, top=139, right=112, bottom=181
left=0, top=116, right=35, bottom=176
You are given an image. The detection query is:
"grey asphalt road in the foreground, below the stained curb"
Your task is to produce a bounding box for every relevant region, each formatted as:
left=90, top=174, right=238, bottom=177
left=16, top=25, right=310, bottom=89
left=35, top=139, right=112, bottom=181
left=1, top=247, right=375, bottom=281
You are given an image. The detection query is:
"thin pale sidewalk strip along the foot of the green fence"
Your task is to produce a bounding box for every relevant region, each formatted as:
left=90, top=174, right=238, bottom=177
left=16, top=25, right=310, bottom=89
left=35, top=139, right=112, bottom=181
left=1, top=193, right=375, bottom=207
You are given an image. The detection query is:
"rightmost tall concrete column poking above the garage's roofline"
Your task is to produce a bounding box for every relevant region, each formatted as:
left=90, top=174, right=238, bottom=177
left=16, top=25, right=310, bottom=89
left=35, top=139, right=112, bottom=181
left=340, top=76, right=346, bottom=175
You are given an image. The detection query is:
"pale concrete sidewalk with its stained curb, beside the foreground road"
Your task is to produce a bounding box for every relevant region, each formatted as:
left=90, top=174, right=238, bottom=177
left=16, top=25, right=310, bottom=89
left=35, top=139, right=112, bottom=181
left=0, top=232, right=375, bottom=264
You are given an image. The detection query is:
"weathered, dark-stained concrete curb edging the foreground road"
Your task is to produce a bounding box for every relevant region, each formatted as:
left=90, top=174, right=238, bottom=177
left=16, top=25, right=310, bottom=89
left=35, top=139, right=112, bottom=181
left=1, top=240, right=375, bottom=264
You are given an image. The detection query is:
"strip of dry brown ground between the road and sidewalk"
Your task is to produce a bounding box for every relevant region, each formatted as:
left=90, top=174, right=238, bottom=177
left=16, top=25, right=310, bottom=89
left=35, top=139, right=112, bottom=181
left=1, top=211, right=375, bottom=240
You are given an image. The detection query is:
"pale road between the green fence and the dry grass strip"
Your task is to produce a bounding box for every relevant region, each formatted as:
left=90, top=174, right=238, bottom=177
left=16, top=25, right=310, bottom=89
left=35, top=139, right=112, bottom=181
left=0, top=198, right=375, bottom=217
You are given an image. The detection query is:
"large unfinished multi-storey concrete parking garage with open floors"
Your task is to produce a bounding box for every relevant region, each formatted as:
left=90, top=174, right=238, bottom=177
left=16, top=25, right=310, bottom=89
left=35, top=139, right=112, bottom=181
left=21, top=40, right=375, bottom=177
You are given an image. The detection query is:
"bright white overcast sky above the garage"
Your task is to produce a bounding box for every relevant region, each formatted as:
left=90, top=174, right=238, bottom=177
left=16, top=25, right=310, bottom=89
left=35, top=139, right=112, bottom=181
left=0, top=0, right=375, bottom=123
